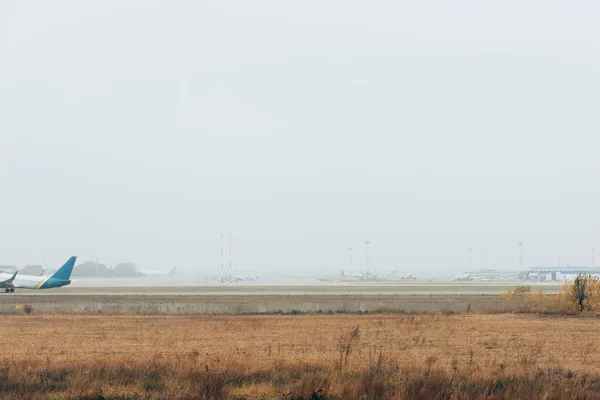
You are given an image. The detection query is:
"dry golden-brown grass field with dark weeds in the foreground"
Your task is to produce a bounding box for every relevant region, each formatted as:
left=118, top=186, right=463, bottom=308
left=0, top=314, right=600, bottom=399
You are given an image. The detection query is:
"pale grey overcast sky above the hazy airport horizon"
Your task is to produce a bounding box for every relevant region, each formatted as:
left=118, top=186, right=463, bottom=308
left=0, top=0, right=600, bottom=276
